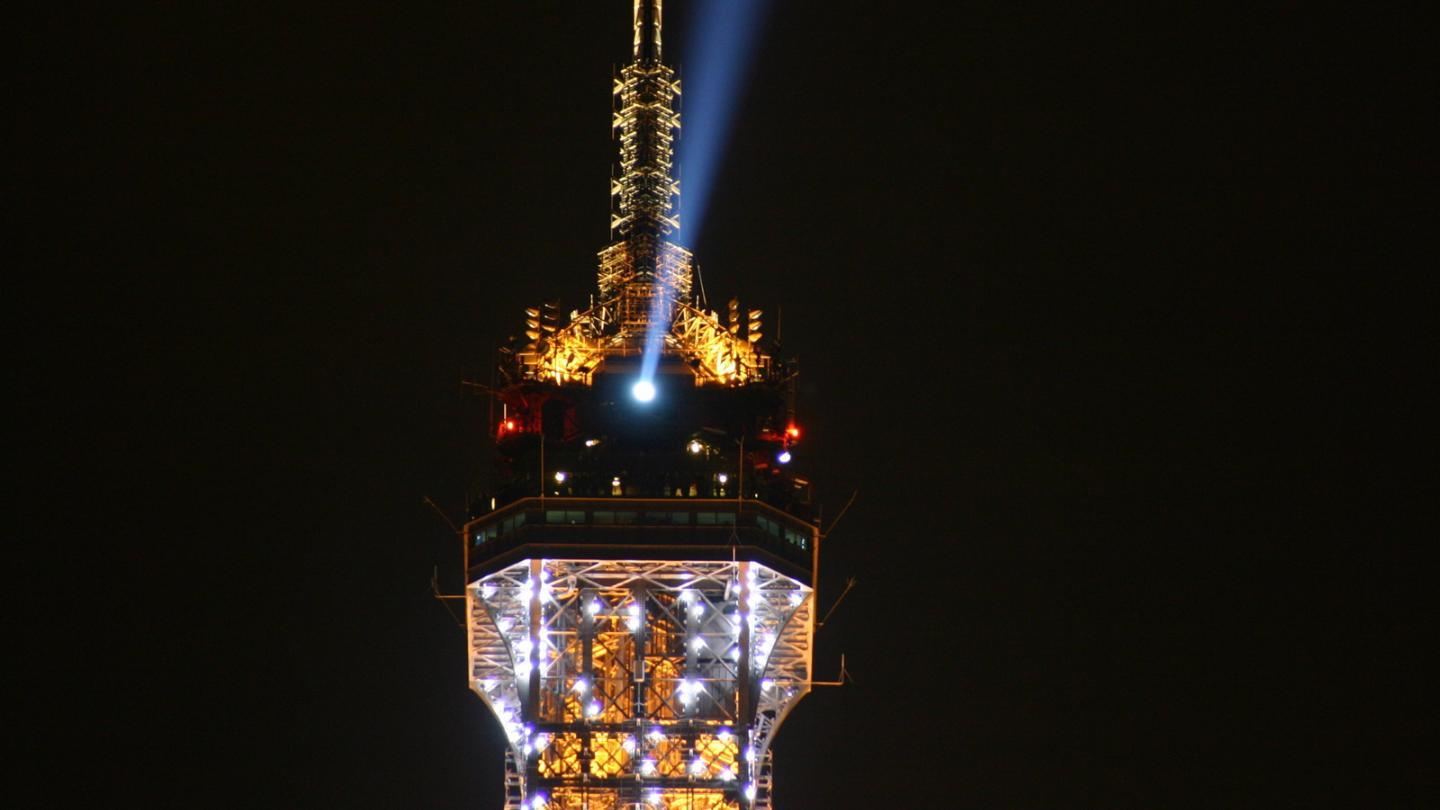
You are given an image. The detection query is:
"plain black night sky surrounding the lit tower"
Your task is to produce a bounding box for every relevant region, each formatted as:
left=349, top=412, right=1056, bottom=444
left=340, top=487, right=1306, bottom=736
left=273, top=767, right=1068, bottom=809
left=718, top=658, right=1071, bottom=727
left=14, top=0, right=1437, bottom=810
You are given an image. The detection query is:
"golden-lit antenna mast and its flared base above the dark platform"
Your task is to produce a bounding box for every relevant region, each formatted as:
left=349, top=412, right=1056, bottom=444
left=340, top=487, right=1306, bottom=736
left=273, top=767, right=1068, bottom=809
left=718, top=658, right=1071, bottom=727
left=517, top=1, right=770, bottom=385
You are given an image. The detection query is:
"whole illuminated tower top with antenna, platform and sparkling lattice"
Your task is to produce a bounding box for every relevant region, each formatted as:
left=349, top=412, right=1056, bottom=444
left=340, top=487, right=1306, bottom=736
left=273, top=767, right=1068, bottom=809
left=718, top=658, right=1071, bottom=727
left=464, top=0, right=819, bottom=810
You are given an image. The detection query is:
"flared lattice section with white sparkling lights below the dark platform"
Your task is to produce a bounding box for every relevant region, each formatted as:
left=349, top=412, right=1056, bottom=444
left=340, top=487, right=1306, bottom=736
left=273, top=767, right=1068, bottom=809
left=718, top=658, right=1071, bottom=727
left=467, top=559, right=815, bottom=810
